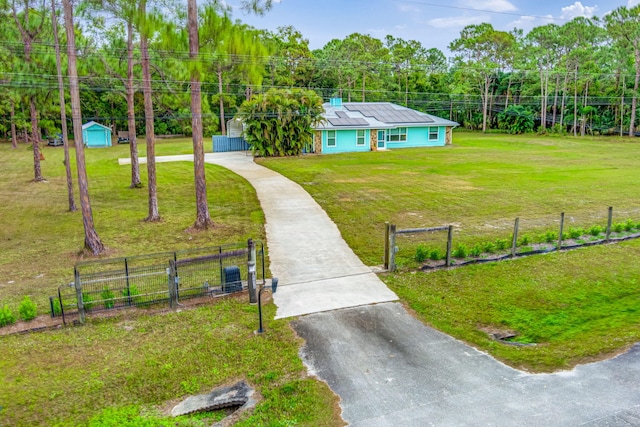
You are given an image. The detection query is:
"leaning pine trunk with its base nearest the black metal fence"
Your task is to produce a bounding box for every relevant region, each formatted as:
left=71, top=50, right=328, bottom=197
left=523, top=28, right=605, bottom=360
left=62, top=0, right=104, bottom=255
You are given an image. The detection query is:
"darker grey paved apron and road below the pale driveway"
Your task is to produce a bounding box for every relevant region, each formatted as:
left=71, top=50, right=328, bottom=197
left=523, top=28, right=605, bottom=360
left=293, top=303, right=640, bottom=426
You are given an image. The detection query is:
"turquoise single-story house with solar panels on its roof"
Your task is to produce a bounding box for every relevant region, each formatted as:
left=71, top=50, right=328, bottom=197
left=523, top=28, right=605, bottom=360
left=313, top=98, right=458, bottom=153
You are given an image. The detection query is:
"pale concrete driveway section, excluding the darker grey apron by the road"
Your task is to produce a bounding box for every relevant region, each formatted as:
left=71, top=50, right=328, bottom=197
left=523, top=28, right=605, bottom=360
left=119, top=152, right=398, bottom=318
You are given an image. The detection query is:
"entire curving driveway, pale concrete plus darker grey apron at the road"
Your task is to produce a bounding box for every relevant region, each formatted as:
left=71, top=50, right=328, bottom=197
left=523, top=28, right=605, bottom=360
left=121, top=153, right=640, bottom=427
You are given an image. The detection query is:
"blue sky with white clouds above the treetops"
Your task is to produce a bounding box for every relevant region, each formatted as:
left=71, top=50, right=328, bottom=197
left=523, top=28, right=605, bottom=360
left=227, top=0, right=640, bottom=56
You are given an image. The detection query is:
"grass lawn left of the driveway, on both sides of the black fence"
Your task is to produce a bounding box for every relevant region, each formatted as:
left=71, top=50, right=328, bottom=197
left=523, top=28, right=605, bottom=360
left=0, top=139, right=342, bottom=426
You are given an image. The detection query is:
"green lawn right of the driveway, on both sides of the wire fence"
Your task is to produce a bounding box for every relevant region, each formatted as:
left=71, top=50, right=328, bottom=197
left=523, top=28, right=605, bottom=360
left=260, top=132, right=640, bottom=371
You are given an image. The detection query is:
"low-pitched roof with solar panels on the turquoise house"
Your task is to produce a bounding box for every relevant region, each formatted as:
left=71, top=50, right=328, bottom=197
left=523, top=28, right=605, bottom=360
left=315, top=102, right=458, bottom=130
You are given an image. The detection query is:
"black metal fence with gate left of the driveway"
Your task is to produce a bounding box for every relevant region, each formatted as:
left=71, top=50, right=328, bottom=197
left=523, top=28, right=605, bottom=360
left=50, top=240, right=265, bottom=323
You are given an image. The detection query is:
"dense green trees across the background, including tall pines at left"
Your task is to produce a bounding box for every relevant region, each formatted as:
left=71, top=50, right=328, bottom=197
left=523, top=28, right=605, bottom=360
left=0, top=0, right=640, bottom=253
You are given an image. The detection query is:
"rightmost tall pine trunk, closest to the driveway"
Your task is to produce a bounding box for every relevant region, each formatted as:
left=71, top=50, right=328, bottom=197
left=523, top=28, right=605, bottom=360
left=187, top=0, right=213, bottom=229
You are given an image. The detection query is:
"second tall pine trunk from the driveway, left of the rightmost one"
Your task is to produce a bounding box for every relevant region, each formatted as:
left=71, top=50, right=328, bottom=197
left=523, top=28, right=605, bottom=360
left=140, top=0, right=160, bottom=222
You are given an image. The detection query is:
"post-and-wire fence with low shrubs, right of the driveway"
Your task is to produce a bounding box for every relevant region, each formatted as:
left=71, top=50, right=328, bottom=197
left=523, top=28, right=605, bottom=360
left=384, top=207, right=640, bottom=271
